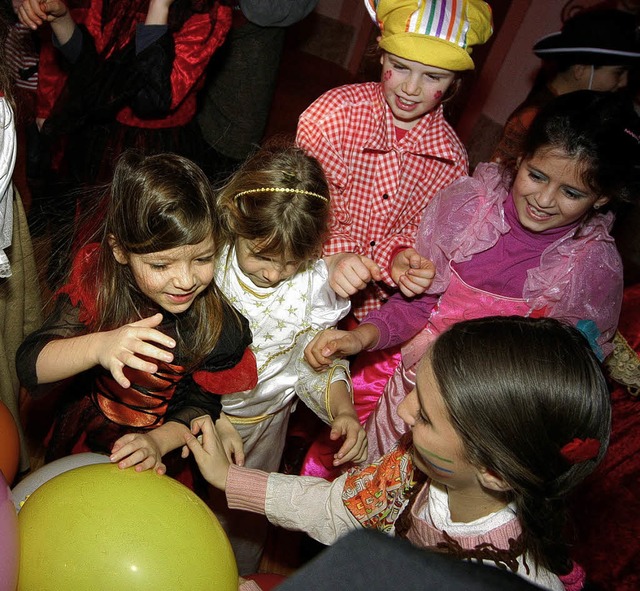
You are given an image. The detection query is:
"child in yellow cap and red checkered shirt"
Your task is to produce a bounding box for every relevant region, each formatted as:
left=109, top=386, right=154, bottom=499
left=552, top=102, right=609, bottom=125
left=296, top=0, right=492, bottom=475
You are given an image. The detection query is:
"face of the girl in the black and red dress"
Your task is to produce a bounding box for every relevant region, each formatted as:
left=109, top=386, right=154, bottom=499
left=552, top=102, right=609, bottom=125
left=112, top=238, right=215, bottom=314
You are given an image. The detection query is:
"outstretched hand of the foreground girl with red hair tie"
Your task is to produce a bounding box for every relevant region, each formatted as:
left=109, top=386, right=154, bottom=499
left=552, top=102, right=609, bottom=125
left=184, top=415, right=229, bottom=490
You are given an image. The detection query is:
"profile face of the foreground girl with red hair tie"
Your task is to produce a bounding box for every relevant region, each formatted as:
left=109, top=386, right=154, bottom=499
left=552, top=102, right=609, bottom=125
left=398, top=358, right=479, bottom=490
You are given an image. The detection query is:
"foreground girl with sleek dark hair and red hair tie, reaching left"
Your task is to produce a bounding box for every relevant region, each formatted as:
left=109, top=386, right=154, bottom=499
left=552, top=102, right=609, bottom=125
left=187, top=317, right=611, bottom=591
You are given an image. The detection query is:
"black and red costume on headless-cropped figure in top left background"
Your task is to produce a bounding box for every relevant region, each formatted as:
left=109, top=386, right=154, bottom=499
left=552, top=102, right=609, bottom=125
left=36, top=0, right=232, bottom=276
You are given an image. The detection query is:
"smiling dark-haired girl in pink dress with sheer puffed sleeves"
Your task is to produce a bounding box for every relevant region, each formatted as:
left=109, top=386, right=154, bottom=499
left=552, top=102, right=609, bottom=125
left=306, top=91, right=640, bottom=459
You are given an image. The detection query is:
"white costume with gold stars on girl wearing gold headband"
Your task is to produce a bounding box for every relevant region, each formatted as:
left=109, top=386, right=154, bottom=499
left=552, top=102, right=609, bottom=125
left=216, top=248, right=350, bottom=471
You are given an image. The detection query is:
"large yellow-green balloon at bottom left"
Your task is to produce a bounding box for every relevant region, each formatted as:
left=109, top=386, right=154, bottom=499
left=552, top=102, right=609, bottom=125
left=18, top=464, right=238, bottom=591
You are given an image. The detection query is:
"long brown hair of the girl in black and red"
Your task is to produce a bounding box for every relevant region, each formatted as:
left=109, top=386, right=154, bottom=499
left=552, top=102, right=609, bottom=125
left=95, top=151, right=234, bottom=365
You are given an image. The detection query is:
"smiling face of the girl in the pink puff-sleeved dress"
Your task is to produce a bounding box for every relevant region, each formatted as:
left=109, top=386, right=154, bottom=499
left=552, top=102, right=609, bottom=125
left=512, top=148, right=608, bottom=232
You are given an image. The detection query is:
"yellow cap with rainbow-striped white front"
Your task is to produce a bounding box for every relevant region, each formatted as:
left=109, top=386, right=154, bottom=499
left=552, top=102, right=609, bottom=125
left=364, top=0, right=493, bottom=72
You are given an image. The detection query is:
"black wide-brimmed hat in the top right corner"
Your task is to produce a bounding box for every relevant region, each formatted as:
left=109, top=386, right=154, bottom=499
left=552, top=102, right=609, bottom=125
left=533, top=10, right=640, bottom=66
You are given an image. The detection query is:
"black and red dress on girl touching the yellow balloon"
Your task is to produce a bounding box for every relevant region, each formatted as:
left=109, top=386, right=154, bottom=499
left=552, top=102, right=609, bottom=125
left=17, top=243, right=257, bottom=484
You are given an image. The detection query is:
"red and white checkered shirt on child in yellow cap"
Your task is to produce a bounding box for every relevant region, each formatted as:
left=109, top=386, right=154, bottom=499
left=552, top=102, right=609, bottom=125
left=296, top=82, right=469, bottom=319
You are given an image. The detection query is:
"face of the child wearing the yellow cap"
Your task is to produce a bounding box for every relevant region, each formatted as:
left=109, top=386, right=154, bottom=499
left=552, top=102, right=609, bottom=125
left=381, top=52, right=456, bottom=129
